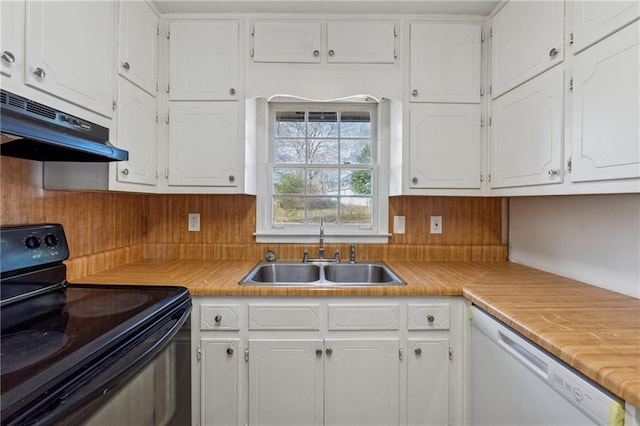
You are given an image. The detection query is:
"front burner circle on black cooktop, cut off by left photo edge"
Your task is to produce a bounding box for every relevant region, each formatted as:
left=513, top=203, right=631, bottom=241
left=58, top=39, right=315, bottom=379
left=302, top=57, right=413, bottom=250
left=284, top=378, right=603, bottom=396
left=0, top=330, right=69, bottom=375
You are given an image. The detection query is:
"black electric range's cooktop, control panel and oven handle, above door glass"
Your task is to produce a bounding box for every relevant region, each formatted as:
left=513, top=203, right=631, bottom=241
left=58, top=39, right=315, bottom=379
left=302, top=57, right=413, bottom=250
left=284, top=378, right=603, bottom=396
left=0, top=224, right=191, bottom=425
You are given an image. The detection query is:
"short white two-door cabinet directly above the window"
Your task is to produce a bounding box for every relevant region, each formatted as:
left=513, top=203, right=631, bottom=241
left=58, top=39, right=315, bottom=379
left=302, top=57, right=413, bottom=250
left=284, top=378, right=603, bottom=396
left=251, top=21, right=397, bottom=64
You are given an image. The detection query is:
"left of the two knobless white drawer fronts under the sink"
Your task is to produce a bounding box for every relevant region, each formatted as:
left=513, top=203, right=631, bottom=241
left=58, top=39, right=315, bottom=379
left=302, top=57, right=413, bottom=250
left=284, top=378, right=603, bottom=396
left=249, top=304, right=320, bottom=330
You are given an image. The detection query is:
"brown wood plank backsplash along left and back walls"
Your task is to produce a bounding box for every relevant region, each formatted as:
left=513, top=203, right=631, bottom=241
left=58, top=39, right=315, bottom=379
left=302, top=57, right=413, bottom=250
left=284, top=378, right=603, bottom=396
left=0, top=157, right=507, bottom=276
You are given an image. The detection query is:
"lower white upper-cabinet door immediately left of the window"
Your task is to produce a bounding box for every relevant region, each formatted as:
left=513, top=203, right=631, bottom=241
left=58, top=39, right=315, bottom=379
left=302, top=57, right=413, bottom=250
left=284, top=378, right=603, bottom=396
left=168, top=102, right=239, bottom=187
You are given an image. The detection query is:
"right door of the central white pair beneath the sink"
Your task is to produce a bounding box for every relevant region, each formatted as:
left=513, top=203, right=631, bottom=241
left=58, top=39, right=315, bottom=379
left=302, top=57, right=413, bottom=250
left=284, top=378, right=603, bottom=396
left=325, top=339, right=400, bottom=425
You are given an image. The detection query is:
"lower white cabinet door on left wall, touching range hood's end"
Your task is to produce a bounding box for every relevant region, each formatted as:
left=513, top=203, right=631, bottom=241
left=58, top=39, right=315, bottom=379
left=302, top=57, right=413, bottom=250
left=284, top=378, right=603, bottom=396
left=116, top=79, right=158, bottom=185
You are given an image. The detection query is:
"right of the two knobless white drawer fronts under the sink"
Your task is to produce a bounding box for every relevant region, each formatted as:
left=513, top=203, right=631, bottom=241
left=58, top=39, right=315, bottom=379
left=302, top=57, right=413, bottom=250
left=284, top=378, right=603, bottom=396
left=329, top=304, right=400, bottom=330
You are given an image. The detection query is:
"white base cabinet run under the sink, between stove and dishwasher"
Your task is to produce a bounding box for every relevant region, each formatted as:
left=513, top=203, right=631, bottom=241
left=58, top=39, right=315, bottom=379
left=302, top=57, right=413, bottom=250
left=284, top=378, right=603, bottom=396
left=192, top=297, right=465, bottom=426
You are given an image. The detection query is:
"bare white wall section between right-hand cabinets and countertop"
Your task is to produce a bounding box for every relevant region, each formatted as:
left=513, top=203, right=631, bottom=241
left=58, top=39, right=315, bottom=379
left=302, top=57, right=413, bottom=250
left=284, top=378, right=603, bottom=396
left=509, top=194, right=640, bottom=298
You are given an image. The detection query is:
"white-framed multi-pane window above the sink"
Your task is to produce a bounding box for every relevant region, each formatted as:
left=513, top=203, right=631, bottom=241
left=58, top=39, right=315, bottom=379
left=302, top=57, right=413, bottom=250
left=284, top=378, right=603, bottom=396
left=257, top=98, right=387, bottom=241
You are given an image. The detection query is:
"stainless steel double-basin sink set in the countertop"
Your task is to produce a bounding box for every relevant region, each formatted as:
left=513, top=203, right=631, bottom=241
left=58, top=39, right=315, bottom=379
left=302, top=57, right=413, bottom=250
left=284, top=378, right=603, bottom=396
left=240, top=261, right=405, bottom=287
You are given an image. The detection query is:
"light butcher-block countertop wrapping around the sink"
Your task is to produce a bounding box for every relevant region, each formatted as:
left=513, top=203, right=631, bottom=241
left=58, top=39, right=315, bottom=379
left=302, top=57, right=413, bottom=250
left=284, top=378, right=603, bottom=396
left=76, top=259, right=640, bottom=407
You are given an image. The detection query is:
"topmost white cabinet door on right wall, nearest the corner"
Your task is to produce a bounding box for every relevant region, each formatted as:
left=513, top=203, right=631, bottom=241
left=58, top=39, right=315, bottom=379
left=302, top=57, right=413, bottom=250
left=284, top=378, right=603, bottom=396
left=491, top=1, right=564, bottom=99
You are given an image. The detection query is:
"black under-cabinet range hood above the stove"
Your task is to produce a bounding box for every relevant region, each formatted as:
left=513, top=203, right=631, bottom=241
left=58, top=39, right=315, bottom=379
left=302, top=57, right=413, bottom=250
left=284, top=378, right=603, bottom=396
left=0, top=90, right=129, bottom=162
